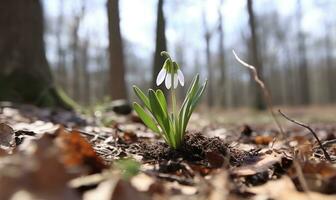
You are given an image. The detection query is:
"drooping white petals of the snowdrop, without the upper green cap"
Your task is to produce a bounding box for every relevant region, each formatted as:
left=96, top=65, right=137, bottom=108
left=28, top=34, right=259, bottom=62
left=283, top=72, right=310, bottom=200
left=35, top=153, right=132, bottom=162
left=156, top=66, right=184, bottom=89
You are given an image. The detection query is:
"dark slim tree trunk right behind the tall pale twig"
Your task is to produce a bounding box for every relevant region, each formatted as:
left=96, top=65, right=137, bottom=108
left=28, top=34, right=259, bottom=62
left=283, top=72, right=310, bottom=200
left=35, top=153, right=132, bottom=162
left=247, top=0, right=266, bottom=110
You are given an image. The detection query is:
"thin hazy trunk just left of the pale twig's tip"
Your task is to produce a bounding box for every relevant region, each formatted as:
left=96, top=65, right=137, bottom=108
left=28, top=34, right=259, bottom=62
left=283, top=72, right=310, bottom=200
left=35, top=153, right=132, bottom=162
left=217, top=0, right=227, bottom=106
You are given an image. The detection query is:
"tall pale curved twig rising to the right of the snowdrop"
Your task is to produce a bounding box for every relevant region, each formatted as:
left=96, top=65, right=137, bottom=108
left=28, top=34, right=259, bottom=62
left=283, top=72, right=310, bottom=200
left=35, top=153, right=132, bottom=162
left=232, top=50, right=285, bottom=144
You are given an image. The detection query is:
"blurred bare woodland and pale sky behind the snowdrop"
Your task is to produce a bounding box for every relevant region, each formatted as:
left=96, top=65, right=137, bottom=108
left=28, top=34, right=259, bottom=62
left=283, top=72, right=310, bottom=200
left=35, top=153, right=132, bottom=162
left=0, top=0, right=336, bottom=109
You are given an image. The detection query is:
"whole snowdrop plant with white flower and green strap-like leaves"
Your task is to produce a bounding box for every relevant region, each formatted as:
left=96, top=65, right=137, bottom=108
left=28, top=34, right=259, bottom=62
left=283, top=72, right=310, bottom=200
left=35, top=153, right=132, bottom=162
left=133, top=51, right=207, bottom=149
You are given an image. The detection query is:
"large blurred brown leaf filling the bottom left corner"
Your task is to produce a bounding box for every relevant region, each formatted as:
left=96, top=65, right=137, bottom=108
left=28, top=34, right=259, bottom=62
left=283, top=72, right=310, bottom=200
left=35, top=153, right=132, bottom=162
left=0, top=136, right=79, bottom=200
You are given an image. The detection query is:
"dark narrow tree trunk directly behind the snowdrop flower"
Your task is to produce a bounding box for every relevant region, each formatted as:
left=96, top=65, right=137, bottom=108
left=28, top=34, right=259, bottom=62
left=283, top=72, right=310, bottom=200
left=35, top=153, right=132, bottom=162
left=152, top=0, right=167, bottom=91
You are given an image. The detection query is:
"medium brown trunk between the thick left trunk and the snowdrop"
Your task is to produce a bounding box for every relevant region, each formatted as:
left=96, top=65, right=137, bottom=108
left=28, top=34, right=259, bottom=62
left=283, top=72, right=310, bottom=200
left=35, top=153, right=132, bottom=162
left=107, top=0, right=127, bottom=100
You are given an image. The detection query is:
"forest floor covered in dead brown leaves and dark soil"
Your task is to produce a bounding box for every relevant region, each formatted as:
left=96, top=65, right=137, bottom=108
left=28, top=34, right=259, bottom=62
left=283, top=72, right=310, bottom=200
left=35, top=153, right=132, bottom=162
left=0, top=103, right=336, bottom=200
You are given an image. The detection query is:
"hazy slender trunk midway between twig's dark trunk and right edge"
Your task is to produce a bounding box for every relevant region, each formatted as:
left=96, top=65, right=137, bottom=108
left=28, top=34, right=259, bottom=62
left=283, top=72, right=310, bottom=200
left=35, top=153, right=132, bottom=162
left=296, top=0, right=310, bottom=105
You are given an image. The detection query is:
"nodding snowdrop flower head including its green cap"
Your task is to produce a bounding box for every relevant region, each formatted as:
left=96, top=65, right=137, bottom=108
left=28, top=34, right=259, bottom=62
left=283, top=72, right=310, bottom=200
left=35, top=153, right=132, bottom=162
left=156, top=53, right=184, bottom=89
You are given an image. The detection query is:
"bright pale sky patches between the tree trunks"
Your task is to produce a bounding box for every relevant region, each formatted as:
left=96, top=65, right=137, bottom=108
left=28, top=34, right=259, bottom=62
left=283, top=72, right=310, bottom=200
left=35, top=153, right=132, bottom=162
left=44, top=0, right=330, bottom=69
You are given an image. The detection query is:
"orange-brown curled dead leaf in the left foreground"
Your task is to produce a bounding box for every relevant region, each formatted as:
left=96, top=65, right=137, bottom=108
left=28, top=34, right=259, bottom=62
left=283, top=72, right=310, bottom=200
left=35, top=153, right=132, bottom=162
left=56, top=128, right=107, bottom=174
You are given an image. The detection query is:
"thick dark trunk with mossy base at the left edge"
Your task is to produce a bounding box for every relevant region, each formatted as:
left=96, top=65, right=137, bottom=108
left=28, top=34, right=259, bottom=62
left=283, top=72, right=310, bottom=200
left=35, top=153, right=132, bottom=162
left=0, top=0, right=67, bottom=107
